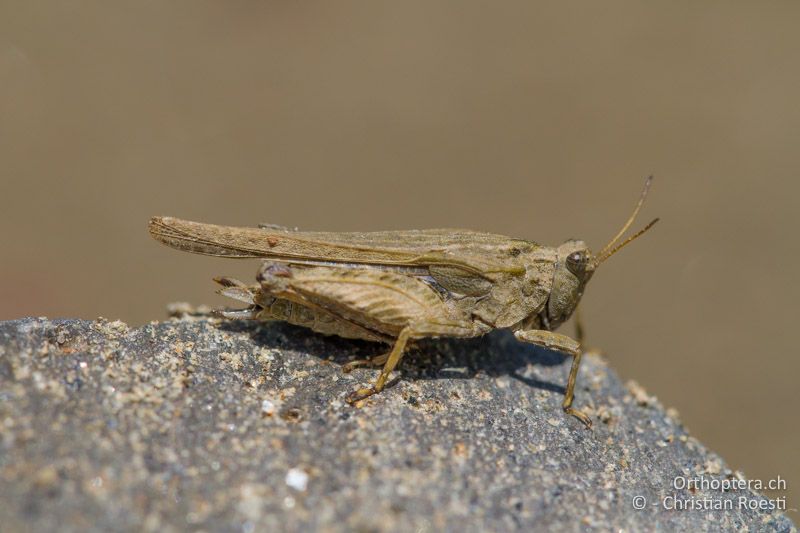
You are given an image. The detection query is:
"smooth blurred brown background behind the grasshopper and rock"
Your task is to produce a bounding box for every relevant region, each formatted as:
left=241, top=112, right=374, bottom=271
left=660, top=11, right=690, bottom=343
left=0, top=0, right=800, bottom=508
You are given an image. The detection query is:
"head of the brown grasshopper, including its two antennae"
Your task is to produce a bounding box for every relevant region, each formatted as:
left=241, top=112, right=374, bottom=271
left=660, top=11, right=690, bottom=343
left=543, top=176, right=658, bottom=329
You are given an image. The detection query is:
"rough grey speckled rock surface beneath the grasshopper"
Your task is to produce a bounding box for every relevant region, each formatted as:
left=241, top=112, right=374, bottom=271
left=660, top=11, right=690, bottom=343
left=0, top=316, right=794, bottom=532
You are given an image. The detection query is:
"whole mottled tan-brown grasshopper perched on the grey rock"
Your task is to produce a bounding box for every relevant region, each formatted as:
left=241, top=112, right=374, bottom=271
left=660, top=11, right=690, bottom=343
left=150, top=177, right=658, bottom=426
